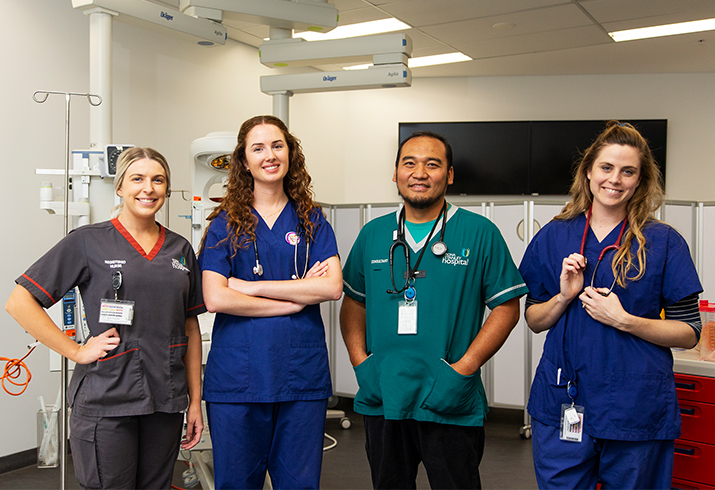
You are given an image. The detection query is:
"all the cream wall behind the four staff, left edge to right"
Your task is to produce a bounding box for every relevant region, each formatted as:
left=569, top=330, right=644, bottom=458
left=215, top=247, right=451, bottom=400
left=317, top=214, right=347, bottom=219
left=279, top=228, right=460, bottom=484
left=0, top=0, right=715, bottom=457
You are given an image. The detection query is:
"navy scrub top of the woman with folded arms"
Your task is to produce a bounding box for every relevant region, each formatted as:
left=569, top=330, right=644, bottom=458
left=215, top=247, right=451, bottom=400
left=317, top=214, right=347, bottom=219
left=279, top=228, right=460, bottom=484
left=199, top=202, right=338, bottom=403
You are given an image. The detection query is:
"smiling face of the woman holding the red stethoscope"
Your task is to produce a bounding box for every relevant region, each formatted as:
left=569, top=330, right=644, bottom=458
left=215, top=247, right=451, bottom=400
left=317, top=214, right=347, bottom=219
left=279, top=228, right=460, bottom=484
left=586, top=144, right=641, bottom=214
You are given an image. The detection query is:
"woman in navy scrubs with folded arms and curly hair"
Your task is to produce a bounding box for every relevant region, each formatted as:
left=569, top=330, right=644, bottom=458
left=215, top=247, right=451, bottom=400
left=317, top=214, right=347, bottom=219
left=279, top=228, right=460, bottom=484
left=199, top=116, right=342, bottom=488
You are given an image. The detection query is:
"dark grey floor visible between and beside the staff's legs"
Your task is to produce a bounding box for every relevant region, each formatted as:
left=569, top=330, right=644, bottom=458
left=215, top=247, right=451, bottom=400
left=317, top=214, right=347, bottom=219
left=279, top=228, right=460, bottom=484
left=0, top=399, right=537, bottom=490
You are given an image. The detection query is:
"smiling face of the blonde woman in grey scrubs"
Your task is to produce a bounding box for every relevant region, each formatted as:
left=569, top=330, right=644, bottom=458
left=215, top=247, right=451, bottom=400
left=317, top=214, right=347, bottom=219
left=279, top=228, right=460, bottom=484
left=117, top=158, right=167, bottom=220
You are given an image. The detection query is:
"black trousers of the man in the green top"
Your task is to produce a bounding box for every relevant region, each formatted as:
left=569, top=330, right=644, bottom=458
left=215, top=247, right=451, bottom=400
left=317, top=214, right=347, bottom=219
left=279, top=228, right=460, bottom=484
left=364, top=415, right=484, bottom=489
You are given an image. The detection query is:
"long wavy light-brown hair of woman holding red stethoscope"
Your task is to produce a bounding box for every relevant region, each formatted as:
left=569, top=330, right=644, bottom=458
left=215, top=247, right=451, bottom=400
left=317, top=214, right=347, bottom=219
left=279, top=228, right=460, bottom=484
left=554, top=121, right=665, bottom=287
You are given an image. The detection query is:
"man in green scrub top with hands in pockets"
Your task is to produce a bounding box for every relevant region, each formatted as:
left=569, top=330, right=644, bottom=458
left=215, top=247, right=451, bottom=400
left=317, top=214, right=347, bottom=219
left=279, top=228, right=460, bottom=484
left=340, top=132, right=527, bottom=488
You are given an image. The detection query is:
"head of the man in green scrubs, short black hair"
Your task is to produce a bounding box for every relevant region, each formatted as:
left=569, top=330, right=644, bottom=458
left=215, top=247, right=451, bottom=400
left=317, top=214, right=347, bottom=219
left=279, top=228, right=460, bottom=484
left=392, top=136, right=454, bottom=217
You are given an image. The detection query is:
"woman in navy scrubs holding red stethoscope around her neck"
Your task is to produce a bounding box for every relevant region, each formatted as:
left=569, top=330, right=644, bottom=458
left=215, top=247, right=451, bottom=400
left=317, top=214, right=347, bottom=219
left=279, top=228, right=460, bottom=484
left=519, top=121, right=702, bottom=489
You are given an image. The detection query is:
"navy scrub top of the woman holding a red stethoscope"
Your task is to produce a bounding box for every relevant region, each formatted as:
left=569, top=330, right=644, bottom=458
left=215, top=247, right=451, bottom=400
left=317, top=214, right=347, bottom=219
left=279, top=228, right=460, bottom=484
left=519, top=215, right=702, bottom=441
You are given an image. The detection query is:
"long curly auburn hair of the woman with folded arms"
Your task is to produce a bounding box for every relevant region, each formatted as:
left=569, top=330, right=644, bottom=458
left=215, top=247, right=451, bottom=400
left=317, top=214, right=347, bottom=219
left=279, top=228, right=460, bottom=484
left=199, top=116, right=322, bottom=255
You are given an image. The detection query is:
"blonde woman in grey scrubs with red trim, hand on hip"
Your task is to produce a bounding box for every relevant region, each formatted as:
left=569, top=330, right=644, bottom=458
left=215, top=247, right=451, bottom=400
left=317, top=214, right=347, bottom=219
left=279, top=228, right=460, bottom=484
left=5, top=148, right=206, bottom=489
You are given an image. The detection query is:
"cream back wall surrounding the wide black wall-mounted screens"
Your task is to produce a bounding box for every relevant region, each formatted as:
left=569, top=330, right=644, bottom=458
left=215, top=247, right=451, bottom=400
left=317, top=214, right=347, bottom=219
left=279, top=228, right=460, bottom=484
left=291, top=73, right=715, bottom=203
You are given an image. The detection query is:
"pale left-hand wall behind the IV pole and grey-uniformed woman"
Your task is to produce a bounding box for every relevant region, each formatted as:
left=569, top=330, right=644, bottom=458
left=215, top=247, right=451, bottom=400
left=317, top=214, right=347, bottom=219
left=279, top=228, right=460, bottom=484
left=0, top=0, right=272, bottom=457
